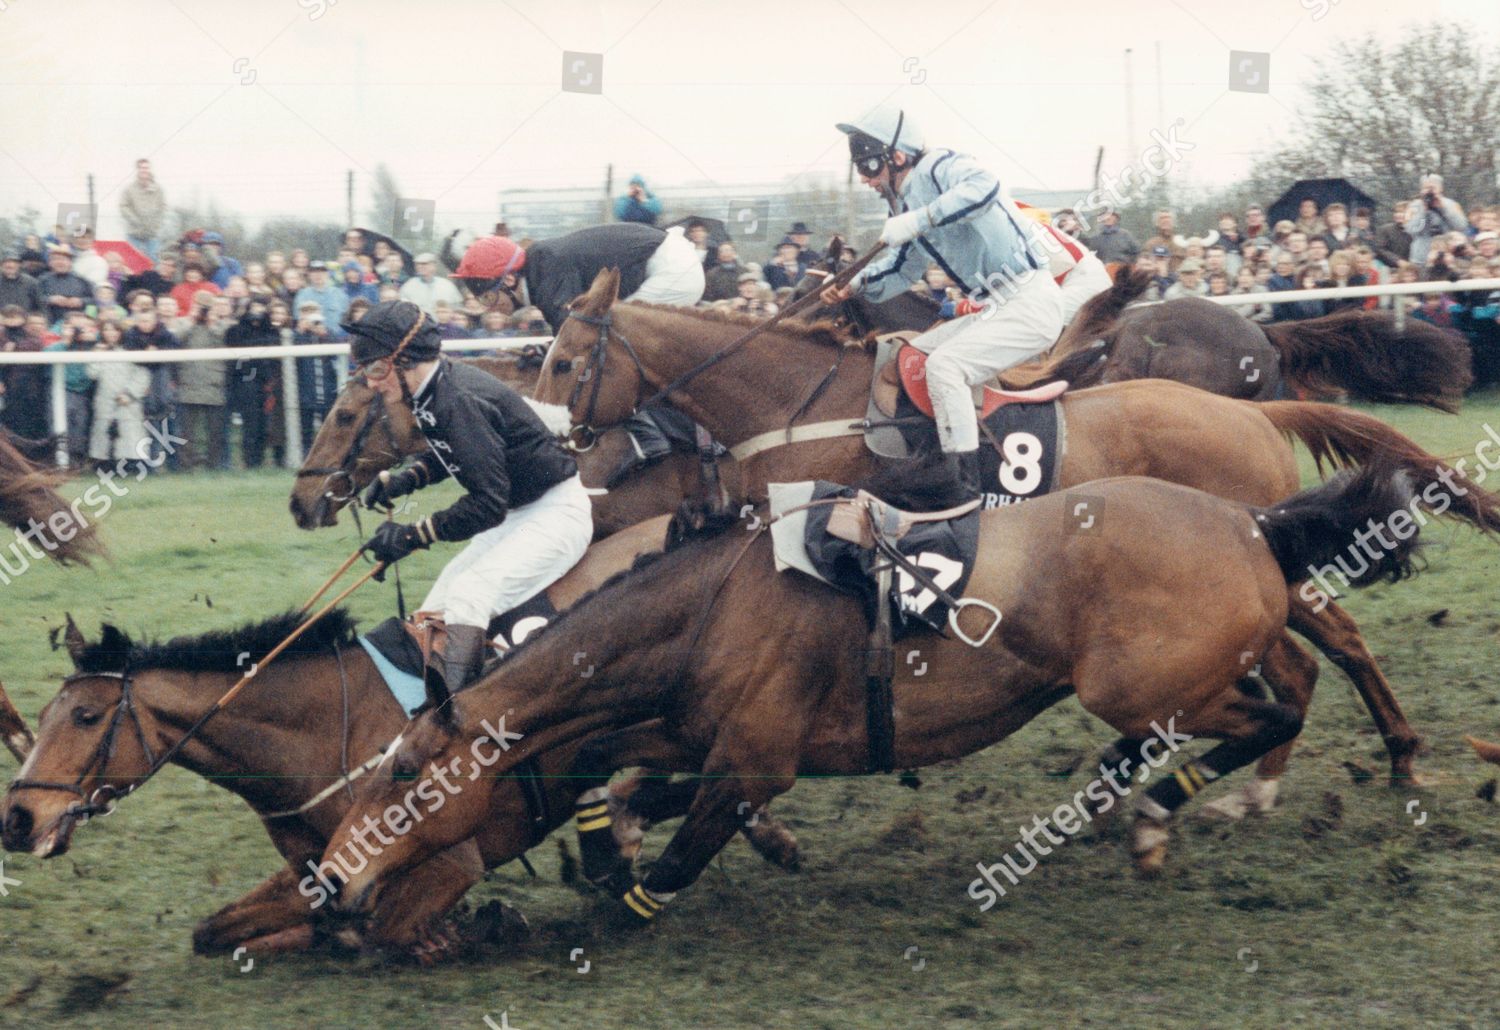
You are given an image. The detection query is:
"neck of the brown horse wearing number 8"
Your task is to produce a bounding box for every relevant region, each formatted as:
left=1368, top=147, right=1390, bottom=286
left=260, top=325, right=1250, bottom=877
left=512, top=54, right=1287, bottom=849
left=615, top=304, right=875, bottom=447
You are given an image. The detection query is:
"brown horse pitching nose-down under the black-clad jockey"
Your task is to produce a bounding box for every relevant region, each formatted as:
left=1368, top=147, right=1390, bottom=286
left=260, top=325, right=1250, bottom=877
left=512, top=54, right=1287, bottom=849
left=0, top=517, right=795, bottom=958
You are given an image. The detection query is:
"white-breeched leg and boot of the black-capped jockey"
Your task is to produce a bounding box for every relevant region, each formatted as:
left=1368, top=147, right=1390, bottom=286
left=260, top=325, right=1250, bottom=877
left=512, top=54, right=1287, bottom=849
left=422, top=475, right=594, bottom=691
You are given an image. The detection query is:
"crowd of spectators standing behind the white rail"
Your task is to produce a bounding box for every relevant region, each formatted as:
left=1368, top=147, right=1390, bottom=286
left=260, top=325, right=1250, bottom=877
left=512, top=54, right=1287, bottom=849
left=0, top=167, right=1500, bottom=471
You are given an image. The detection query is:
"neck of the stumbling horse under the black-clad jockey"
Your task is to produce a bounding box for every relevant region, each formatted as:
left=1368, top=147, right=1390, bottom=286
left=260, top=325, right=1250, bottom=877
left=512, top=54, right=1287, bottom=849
left=135, top=648, right=387, bottom=808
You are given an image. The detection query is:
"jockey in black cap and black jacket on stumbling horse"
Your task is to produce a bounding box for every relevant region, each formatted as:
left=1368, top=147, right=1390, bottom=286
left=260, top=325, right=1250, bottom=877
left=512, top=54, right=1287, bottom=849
left=344, top=300, right=594, bottom=693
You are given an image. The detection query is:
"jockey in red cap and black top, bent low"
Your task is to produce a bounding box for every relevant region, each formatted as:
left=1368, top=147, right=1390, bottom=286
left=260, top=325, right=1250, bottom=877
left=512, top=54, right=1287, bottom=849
left=453, top=222, right=704, bottom=333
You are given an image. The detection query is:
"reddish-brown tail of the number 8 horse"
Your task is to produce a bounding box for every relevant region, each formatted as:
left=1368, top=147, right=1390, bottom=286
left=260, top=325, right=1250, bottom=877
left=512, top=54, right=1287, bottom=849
left=1260, top=400, right=1500, bottom=532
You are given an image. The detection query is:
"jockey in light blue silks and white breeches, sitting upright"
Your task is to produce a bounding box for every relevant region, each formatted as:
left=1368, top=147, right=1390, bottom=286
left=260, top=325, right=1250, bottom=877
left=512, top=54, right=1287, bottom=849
left=822, top=106, right=1062, bottom=499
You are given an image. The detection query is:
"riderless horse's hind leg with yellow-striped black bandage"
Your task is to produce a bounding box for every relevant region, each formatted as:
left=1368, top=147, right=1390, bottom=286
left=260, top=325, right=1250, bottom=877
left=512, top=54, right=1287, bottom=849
left=1131, top=685, right=1304, bottom=876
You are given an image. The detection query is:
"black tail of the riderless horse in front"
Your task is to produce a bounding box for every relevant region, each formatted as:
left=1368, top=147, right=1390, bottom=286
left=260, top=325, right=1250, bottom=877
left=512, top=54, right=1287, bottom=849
left=1250, top=460, right=1424, bottom=586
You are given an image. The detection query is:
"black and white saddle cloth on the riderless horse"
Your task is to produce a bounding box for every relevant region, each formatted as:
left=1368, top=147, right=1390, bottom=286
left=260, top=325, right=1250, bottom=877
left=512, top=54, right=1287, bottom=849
left=768, top=480, right=980, bottom=637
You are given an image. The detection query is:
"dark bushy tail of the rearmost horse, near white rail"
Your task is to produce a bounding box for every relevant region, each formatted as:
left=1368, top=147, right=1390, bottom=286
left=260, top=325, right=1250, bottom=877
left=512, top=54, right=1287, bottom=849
left=1262, top=309, right=1475, bottom=412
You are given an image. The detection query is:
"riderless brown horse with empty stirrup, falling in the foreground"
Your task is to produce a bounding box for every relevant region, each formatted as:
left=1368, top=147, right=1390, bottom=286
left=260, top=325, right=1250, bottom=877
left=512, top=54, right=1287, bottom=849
left=324, top=465, right=1418, bottom=919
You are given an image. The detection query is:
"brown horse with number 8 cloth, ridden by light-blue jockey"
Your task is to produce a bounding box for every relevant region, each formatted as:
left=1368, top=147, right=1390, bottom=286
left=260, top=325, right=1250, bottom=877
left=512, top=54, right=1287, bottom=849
left=537, top=273, right=1500, bottom=810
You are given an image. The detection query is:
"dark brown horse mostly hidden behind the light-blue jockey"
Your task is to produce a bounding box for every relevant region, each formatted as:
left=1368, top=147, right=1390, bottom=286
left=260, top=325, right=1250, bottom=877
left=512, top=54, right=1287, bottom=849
left=797, top=237, right=1473, bottom=412
